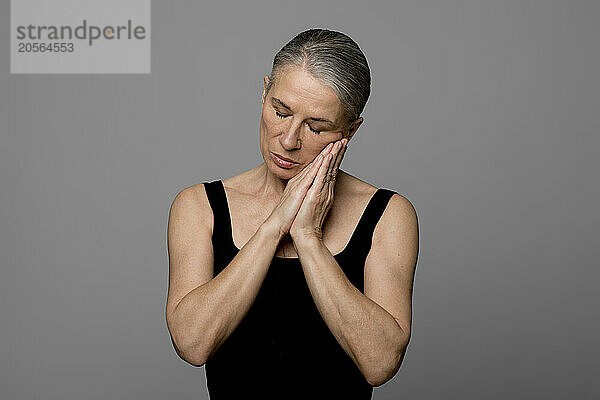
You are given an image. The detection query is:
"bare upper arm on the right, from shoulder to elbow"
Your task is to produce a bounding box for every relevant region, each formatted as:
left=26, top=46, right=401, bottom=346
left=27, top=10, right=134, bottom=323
left=364, top=194, right=419, bottom=341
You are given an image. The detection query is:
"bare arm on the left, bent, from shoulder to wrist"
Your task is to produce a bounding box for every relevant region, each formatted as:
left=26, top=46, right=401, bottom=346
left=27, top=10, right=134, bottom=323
left=166, top=184, right=281, bottom=366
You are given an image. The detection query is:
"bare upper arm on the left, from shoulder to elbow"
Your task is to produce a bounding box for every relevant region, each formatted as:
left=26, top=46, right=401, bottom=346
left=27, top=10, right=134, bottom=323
left=166, top=184, right=214, bottom=323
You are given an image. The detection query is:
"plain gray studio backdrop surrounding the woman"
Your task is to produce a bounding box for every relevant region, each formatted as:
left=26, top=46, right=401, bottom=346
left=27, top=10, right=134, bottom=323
left=0, top=0, right=600, bottom=400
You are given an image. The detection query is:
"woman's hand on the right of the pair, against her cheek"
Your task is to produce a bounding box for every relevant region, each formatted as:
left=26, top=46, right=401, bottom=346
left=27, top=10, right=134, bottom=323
left=290, top=139, right=348, bottom=241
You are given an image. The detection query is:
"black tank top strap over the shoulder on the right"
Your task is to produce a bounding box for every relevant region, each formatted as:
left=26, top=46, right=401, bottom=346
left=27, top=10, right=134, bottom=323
left=348, top=188, right=397, bottom=264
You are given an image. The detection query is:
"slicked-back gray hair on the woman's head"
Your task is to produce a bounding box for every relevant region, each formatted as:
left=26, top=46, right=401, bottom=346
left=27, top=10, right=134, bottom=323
left=265, top=29, right=371, bottom=131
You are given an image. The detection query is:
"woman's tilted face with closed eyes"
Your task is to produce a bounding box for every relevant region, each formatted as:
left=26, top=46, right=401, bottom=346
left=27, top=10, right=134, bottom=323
left=260, top=67, right=362, bottom=179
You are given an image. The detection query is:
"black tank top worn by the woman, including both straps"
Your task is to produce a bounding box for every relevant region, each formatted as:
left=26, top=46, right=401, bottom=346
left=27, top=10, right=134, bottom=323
left=203, top=180, right=396, bottom=400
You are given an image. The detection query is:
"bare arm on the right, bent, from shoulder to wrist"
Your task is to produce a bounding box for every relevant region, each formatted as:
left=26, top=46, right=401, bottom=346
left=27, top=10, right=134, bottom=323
left=294, top=194, right=418, bottom=386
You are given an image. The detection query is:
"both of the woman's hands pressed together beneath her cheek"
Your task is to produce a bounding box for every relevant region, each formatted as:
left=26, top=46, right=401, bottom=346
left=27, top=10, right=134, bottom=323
left=270, top=139, right=348, bottom=247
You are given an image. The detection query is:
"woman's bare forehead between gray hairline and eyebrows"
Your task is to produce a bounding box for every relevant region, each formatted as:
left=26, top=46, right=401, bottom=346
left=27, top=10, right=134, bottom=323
left=272, top=67, right=342, bottom=118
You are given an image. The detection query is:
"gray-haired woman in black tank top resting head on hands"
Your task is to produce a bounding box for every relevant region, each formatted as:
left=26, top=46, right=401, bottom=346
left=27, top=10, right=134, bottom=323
left=166, top=29, right=418, bottom=400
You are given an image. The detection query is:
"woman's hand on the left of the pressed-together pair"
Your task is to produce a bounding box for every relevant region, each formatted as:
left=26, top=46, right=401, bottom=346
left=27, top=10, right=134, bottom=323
left=265, top=142, right=335, bottom=237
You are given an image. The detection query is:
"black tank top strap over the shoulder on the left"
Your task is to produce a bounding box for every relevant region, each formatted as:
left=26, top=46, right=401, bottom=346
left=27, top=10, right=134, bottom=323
left=203, top=180, right=235, bottom=252
